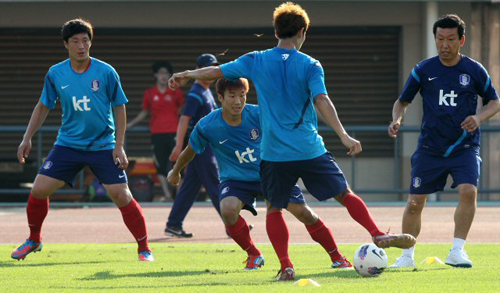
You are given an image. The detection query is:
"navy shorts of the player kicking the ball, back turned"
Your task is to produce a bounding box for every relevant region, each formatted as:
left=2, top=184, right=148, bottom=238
left=260, top=153, right=348, bottom=208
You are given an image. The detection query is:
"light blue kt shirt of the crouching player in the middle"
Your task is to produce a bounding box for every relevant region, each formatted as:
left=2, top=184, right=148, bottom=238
left=189, top=104, right=261, bottom=182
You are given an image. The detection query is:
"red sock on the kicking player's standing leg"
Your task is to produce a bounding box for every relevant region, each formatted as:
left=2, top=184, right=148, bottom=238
left=266, top=211, right=293, bottom=270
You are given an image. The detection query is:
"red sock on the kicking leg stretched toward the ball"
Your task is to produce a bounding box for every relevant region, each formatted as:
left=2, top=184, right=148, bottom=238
left=344, top=193, right=385, bottom=237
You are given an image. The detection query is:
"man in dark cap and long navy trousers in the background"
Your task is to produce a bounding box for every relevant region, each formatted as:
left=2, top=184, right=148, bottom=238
left=164, top=53, right=220, bottom=238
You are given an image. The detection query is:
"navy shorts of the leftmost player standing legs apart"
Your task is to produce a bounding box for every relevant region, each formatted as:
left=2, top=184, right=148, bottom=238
left=38, top=145, right=127, bottom=186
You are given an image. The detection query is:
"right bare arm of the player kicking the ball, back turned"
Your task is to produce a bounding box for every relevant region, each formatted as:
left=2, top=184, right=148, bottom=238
left=314, top=94, right=363, bottom=156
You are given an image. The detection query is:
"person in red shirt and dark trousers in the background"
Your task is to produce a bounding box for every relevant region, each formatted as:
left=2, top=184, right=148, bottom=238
left=127, top=61, right=184, bottom=199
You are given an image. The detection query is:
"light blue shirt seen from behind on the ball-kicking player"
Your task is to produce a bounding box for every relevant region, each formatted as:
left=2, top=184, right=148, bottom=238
left=220, top=47, right=327, bottom=162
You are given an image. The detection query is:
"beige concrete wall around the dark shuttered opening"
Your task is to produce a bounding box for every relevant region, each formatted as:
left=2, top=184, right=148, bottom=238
left=0, top=1, right=482, bottom=200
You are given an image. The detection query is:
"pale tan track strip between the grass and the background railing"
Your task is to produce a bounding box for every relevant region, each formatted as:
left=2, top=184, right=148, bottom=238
left=0, top=206, right=500, bottom=244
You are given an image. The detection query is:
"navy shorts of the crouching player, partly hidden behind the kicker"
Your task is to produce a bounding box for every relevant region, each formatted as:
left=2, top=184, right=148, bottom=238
left=219, top=180, right=306, bottom=216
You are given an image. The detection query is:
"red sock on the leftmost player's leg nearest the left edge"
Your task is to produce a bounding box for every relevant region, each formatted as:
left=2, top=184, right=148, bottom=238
left=26, top=193, right=49, bottom=243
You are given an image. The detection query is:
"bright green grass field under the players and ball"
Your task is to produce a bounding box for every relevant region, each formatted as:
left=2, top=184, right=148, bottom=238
left=0, top=243, right=500, bottom=293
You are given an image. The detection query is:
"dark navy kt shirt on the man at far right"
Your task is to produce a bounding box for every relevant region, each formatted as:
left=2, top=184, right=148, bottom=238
left=399, top=55, right=498, bottom=157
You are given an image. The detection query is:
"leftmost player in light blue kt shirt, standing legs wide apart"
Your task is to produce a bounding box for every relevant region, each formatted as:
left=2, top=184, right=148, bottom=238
left=12, top=19, right=154, bottom=261
